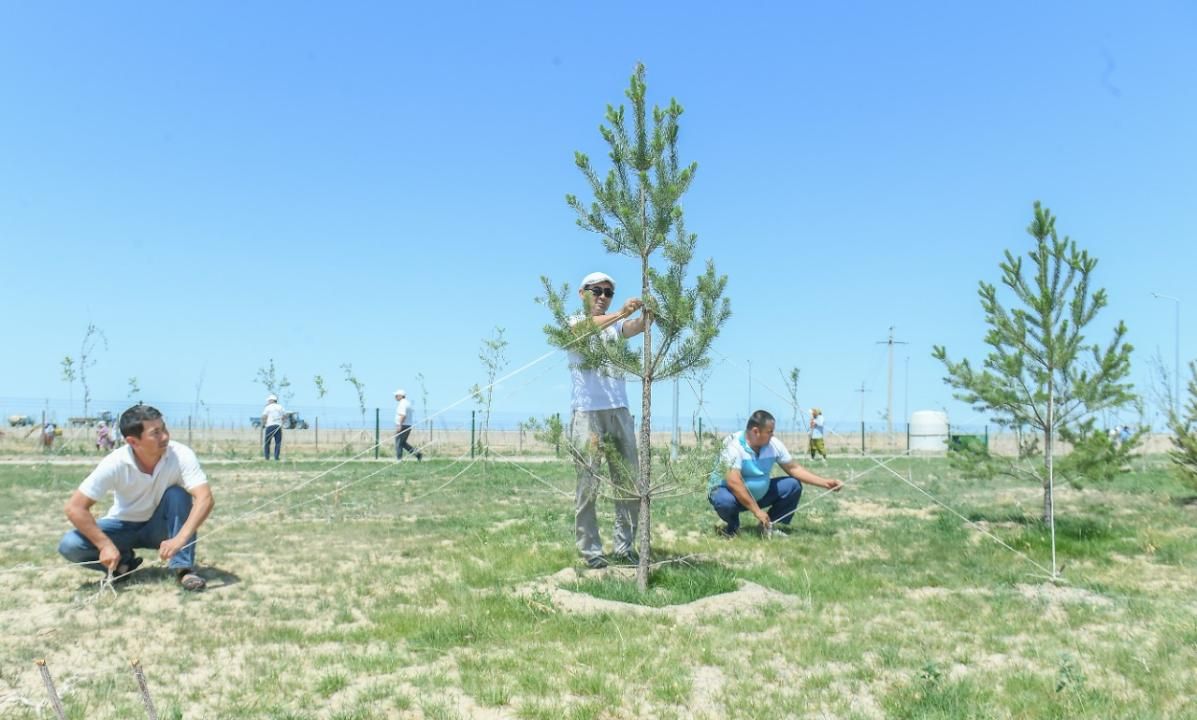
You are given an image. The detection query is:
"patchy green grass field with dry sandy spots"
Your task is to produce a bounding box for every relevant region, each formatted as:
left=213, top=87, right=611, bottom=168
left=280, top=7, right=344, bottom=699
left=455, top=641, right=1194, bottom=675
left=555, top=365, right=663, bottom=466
left=0, top=458, right=1197, bottom=720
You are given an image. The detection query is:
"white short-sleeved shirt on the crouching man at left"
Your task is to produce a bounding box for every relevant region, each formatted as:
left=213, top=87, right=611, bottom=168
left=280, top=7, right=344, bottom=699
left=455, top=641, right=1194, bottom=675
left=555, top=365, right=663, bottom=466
left=79, top=440, right=208, bottom=523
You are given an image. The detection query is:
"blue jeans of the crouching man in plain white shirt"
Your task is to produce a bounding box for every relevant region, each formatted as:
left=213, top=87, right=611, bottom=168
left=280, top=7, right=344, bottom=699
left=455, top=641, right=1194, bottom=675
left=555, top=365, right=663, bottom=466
left=59, top=486, right=195, bottom=573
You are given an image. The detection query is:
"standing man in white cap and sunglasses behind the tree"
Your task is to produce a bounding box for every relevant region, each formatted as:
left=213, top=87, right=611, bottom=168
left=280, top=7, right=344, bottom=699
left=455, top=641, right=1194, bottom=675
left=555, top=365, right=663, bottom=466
left=570, top=273, right=644, bottom=569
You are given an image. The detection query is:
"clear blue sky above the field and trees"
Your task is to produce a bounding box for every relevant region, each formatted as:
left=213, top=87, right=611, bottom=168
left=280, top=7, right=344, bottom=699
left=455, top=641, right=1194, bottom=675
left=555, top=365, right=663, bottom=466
left=0, top=0, right=1197, bottom=426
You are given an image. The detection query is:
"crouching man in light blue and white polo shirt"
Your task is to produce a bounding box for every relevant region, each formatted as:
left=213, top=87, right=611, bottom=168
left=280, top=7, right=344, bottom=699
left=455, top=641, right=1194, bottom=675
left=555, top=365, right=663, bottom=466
left=707, top=410, right=844, bottom=536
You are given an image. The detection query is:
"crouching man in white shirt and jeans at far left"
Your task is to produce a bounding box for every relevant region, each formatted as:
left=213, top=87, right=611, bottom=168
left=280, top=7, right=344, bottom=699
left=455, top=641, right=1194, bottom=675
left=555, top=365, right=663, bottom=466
left=59, top=404, right=213, bottom=591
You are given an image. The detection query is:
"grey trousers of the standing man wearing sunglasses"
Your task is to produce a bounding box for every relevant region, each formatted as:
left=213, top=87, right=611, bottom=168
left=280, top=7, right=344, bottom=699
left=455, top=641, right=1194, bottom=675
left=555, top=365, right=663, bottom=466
left=570, top=408, right=640, bottom=559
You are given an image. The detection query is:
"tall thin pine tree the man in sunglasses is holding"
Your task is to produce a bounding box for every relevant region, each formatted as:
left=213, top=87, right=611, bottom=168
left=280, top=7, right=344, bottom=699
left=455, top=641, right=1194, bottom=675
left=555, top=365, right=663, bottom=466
left=541, top=65, right=731, bottom=592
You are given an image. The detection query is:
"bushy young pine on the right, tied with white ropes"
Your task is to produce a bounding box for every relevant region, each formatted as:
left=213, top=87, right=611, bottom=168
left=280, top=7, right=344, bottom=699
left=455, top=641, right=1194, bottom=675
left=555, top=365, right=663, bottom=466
left=932, top=202, right=1134, bottom=538
